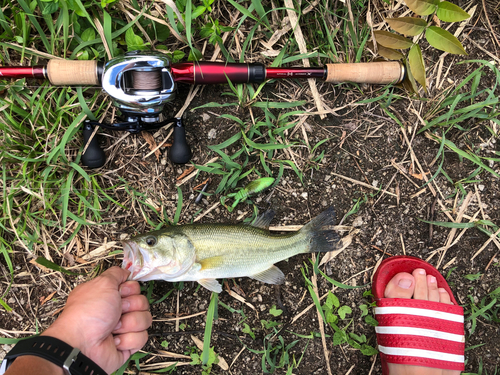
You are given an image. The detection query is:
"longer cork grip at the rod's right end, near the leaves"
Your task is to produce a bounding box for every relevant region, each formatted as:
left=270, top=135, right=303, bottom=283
left=325, top=61, right=404, bottom=84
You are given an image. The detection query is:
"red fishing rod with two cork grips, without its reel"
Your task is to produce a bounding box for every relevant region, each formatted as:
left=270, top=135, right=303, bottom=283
left=0, top=53, right=405, bottom=86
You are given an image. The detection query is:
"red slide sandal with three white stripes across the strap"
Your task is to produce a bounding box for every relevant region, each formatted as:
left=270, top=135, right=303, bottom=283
left=372, top=256, right=465, bottom=374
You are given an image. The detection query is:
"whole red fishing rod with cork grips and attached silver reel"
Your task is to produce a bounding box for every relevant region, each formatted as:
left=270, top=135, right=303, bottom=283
left=0, top=51, right=405, bottom=168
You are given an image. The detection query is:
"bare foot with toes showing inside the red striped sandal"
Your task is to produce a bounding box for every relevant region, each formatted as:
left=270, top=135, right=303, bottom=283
left=384, top=268, right=460, bottom=375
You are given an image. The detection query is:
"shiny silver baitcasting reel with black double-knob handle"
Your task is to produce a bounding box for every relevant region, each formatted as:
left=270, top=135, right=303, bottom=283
left=82, top=51, right=191, bottom=168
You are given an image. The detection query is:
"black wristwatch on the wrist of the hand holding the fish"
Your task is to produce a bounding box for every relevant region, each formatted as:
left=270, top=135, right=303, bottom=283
left=0, top=336, right=107, bottom=375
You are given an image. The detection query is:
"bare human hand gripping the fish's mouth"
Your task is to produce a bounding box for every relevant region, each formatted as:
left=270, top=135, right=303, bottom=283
left=42, top=267, right=152, bottom=373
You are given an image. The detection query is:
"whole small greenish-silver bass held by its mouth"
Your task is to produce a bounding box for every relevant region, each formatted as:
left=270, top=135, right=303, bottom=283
left=122, top=207, right=341, bottom=293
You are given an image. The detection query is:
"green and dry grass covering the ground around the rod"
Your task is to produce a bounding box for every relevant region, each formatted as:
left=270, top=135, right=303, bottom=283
left=0, top=0, right=500, bottom=374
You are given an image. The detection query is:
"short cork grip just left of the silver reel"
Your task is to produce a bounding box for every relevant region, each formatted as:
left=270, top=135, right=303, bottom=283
left=47, top=60, right=99, bottom=86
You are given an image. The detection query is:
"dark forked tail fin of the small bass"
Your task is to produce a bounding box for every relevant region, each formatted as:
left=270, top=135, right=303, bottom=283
left=300, top=207, right=340, bottom=253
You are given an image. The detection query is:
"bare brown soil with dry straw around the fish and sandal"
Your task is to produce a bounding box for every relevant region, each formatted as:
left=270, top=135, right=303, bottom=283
left=0, top=1, right=500, bottom=375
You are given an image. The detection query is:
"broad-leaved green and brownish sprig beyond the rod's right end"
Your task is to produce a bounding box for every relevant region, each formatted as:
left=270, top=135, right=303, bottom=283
left=374, top=0, right=470, bottom=92
